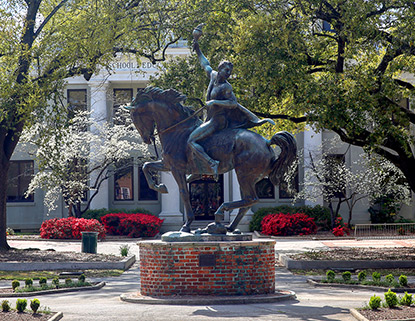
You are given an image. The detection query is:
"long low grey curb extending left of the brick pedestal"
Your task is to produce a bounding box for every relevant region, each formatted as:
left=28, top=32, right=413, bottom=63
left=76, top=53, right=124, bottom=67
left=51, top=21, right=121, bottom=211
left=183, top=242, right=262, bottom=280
left=0, top=255, right=136, bottom=271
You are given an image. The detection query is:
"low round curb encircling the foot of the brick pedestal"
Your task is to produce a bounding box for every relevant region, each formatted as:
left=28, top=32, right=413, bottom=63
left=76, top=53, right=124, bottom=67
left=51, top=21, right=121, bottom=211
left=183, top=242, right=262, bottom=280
left=120, top=290, right=296, bottom=305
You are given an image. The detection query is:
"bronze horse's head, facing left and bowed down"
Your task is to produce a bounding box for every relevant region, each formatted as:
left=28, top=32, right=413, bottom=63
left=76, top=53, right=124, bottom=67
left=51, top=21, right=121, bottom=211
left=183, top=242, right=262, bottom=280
left=125, top=89, right=155, bottom=144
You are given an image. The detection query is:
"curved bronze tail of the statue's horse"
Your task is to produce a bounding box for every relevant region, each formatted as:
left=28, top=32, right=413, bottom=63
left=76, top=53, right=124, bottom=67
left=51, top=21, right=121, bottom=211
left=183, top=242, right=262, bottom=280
left=268, top=131, right=297, bottom=185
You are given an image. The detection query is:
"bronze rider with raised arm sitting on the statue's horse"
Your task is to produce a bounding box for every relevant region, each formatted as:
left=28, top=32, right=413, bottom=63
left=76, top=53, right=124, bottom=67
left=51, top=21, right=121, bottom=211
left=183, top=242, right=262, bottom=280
left=187, top=25, right=274, bottom=176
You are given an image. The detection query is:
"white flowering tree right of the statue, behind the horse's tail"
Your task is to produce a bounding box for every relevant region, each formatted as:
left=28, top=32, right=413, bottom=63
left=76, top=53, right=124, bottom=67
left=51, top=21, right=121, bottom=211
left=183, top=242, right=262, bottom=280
left=286, top=140, right=410, bottom=227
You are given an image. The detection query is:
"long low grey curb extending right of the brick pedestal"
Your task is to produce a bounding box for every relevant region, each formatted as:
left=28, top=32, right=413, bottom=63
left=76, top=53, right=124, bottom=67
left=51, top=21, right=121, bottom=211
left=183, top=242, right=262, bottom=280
left=278, top=254, right=415, bottom=270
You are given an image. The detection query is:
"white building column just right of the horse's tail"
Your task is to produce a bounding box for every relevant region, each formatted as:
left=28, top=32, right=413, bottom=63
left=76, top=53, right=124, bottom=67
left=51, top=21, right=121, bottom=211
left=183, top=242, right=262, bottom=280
left=304, top=126, right=323, bottom=206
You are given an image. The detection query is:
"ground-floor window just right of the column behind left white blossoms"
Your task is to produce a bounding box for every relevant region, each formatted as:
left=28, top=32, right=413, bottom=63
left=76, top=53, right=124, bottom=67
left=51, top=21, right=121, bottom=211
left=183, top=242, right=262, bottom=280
left=114, top=159, right=134, bottom=201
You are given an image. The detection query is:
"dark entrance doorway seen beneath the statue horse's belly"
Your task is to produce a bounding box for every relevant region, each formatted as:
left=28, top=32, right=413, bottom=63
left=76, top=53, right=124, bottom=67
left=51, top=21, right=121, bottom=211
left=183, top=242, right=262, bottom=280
left=189, top=175, right=223, bottom=220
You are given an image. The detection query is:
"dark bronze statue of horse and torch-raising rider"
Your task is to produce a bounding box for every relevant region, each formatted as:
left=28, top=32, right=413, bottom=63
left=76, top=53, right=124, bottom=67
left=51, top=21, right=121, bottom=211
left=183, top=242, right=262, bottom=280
left=126, top=24, right=297, bottom=234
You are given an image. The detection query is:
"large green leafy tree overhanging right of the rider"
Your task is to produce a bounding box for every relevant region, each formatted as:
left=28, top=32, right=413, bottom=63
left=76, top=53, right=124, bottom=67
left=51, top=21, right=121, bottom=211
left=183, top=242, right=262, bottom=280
left=154, top=0, right=415, bottom=191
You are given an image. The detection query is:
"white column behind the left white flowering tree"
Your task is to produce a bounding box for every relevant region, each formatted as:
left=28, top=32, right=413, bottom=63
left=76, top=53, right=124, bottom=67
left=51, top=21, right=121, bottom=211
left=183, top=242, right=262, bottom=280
left=88, top=81, right=109, bottom=209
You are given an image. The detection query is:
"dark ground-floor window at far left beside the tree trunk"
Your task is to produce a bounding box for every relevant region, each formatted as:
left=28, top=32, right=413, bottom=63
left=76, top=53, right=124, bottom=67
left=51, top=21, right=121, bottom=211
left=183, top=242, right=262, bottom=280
left=7, top=161, right=34, bottom=202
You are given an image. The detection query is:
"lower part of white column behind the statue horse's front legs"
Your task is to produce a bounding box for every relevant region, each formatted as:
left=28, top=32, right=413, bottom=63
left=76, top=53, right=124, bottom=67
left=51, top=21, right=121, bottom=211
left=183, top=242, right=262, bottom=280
left=159, top=172, right=184, bottom=232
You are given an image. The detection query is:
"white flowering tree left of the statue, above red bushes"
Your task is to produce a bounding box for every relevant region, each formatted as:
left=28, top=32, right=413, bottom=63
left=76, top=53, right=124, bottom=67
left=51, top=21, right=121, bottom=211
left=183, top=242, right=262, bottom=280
left=22, top=111, right=150, bottom=217
